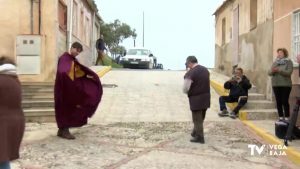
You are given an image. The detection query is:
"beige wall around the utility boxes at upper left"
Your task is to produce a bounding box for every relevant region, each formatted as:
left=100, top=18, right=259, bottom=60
left=0, top=0, right=57, bottom=81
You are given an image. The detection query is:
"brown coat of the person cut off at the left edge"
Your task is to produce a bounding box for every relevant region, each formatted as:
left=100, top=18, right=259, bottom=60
left=0, top=74, right=25, bottom=163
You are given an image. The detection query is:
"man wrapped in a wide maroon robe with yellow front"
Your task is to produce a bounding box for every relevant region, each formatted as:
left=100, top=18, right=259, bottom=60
left=54, top=42, right=103, bottom=139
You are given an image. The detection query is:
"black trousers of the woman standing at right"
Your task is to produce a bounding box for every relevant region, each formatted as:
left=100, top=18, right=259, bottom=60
left=273, top=87, right=292, bottom=117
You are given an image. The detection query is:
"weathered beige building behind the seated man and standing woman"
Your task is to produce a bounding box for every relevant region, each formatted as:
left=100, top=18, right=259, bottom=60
left=214, top=0, right=300, bottom=99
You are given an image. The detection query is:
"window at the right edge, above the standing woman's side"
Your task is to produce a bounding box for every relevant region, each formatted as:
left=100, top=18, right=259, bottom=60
left=292, top=11, right=300, bottom=62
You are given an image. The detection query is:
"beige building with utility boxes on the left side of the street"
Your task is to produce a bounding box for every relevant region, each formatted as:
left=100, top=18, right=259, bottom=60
left=0, top=0, right=101, bottom=82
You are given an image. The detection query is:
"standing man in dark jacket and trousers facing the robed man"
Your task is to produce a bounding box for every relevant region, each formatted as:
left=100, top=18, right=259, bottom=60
left=183, top=56, right=210, bottom=144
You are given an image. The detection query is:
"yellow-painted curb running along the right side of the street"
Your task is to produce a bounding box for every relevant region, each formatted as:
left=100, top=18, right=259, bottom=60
left=210, top=80, right=300, bottom=166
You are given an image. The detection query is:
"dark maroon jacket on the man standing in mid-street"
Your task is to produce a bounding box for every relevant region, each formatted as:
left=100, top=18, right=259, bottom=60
left=185, top=65, right=210, bottom=111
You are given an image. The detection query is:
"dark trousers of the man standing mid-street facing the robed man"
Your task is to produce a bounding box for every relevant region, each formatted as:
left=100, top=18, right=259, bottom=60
left=192, top=109, right=207, bottom=137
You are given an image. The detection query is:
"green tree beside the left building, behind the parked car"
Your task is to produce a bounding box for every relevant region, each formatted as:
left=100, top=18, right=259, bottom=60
left=100, top=19, right=137, bottom=56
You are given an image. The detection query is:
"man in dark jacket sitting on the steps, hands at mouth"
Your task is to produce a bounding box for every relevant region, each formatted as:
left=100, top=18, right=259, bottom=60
left=219, top=68, right=252, bottom=119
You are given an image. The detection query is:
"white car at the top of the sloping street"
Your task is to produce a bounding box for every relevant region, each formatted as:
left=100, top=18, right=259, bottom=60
left=121, top=48, right=156, bottom=69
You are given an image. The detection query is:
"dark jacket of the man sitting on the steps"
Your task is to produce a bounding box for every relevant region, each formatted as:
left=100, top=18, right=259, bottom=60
left=224, top=75, right=252, bottom=98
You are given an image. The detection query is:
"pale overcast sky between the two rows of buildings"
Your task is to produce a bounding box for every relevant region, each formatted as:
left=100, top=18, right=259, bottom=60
left=96, top=0, right=223, bottom=70
